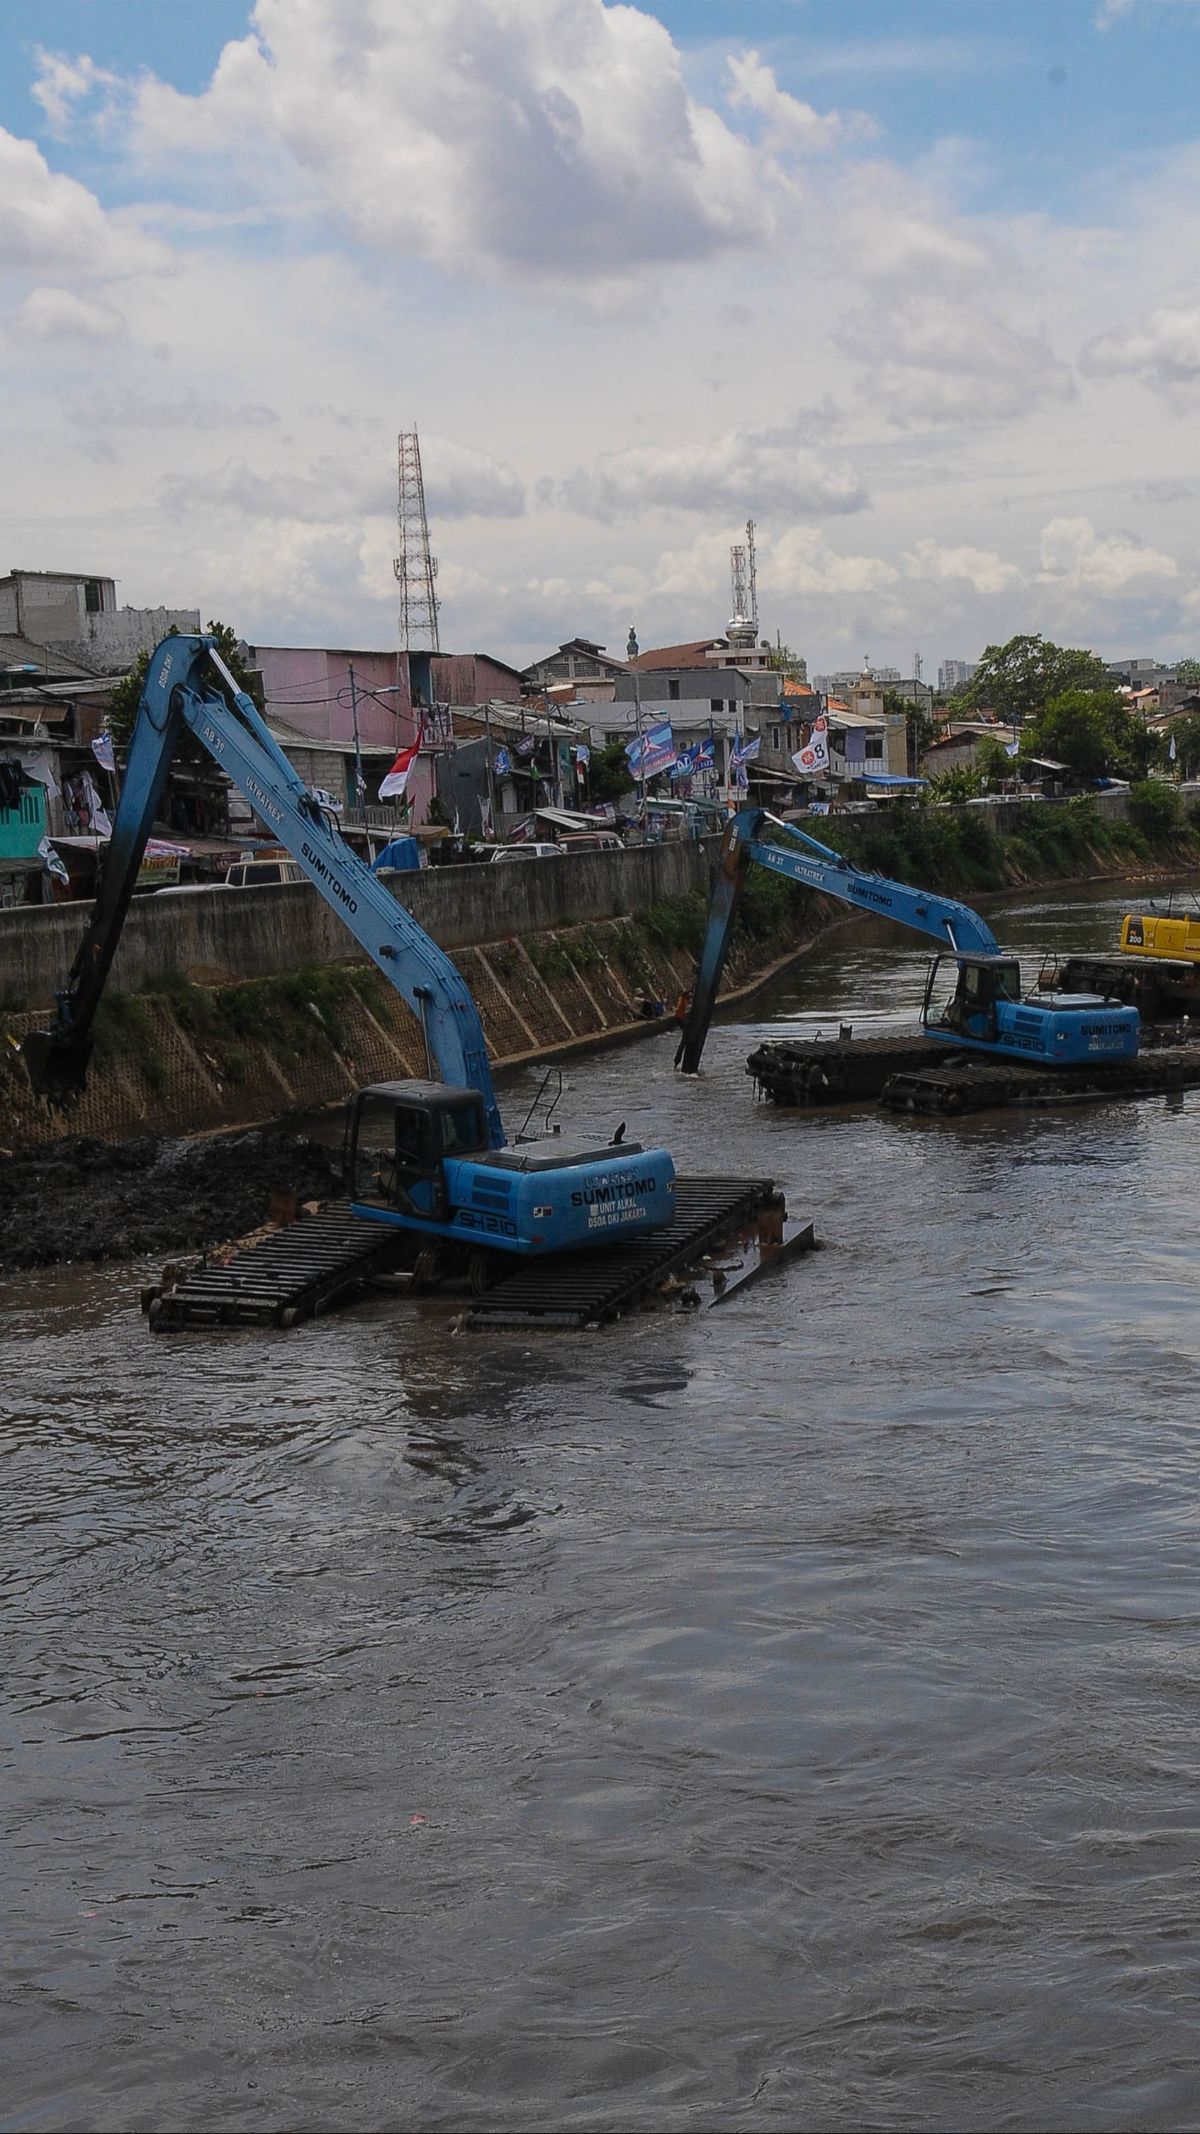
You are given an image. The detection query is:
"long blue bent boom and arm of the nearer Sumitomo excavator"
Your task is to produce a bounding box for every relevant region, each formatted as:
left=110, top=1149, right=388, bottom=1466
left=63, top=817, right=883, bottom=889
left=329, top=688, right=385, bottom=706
left=26, top=638, right=504, bottom=1148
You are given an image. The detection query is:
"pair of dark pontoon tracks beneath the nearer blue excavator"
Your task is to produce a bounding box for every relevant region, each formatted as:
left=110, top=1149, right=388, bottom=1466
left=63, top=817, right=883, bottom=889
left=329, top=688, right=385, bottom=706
left=143, top=1178, right=814, bottom=1334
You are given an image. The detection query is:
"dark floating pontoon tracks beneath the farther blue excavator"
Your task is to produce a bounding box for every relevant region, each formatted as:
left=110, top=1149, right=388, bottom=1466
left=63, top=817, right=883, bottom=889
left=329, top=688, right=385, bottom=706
left=745, top=1037, right=1200, bottom=1116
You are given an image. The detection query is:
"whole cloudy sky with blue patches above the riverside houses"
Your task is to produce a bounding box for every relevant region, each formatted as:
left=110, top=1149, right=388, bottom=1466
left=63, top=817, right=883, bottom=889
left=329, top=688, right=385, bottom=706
left=0, top=0, right=1200, bottom=676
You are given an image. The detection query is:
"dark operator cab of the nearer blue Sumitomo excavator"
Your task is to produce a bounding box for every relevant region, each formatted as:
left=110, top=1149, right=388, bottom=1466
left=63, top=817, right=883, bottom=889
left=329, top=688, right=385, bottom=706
left=344, top=1082, right=489, bottom=1223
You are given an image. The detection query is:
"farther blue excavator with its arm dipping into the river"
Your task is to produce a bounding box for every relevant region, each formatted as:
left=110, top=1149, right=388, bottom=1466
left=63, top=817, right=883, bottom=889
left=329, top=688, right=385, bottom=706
left=675, top=807, right=1140, bottom=1073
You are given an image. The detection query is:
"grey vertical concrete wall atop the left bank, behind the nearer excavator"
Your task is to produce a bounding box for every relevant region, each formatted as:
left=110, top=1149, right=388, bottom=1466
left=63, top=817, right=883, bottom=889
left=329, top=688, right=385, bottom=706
left=0, top=839, right=720, bottom=1009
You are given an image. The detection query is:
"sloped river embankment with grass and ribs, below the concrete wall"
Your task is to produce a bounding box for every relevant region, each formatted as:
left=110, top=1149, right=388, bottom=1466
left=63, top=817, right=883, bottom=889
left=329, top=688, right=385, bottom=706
left=0, top=794, right=1200, bottom=1150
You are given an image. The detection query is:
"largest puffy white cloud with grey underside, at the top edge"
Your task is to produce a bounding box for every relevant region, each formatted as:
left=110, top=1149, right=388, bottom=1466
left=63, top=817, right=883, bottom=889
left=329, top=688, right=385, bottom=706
left=79, top=0, right=764, bottom=277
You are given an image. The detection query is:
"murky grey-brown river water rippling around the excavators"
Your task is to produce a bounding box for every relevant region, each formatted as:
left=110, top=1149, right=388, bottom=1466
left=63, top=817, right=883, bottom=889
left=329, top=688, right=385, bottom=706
left=0, top=890, right=1200, bottom=2130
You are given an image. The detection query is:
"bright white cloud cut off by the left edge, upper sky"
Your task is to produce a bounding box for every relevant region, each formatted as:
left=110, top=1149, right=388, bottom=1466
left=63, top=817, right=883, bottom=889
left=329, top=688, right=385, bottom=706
left=0, top=126, right=169, bottom=280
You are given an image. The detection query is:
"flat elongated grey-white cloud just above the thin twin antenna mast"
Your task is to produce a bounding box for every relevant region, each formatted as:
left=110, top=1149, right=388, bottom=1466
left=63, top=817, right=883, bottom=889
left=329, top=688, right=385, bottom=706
left=542, top=420, right=867, bottom=523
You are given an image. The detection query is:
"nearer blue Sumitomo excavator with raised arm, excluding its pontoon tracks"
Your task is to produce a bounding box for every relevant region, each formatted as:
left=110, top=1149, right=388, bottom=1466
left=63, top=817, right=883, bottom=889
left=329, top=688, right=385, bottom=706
left=23, top=636, right=675, bottom=1274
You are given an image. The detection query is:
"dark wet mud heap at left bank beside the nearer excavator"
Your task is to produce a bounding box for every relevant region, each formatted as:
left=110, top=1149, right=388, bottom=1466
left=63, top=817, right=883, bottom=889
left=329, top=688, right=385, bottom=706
left=0, top=1131, right=340, bottom=1268
